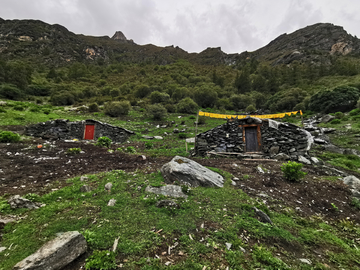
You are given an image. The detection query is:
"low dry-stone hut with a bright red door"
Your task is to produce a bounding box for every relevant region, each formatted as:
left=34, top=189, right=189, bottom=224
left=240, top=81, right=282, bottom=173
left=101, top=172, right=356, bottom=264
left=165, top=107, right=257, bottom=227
left=25, top=119, right=135, bottom=142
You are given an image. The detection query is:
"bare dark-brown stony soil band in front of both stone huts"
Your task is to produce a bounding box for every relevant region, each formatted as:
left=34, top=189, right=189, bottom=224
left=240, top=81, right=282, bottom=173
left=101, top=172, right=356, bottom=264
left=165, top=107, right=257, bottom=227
left=0, top=133, right=360, bottom=223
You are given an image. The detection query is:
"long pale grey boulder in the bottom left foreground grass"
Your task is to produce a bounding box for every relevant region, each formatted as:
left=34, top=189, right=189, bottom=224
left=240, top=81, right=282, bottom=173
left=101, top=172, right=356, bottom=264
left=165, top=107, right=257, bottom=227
left=13, top=231, right=87, bottom=270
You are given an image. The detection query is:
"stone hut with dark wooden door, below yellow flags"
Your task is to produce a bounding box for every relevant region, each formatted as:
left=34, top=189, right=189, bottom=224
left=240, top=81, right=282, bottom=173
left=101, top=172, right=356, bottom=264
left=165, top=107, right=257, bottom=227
left=194, top=117, right=312, bottom=159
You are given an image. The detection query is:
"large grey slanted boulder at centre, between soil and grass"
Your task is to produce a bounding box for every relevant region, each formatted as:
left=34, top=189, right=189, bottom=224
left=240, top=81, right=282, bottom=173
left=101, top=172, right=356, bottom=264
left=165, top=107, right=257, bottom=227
left=161, top=156, right=224, bottom=187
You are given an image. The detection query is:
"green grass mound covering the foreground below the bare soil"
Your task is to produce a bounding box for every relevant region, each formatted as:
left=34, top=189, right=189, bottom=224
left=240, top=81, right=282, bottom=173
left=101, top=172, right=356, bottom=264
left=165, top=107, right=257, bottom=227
left=0, top=168, right=360, bottom=270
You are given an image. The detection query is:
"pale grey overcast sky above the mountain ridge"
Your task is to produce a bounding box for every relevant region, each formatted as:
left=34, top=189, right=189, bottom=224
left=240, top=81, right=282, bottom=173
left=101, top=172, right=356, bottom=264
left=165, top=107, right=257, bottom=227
left=0, top=0, right=360, bottom=53
